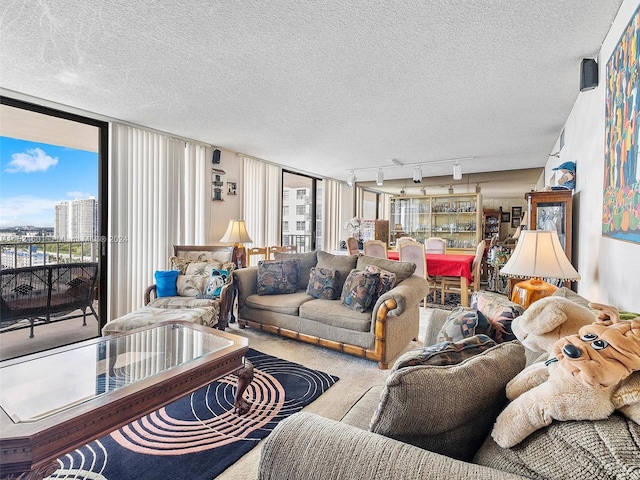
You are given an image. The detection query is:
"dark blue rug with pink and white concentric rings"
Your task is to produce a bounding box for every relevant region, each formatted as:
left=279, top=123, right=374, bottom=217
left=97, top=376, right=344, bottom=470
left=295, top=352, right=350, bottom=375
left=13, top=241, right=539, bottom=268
left=47, top=349, right=338, bottom=480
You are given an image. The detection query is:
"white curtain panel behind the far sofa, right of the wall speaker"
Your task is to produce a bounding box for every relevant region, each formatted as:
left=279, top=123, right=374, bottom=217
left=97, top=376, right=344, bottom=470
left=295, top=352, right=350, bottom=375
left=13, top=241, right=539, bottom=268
left=242, top=157, right=282, bottom=251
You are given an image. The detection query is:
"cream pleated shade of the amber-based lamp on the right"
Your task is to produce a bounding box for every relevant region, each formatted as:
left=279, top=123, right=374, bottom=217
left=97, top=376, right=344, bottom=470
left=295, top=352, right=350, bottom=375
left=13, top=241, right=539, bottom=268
left=500, top=230, right=580, bottom=280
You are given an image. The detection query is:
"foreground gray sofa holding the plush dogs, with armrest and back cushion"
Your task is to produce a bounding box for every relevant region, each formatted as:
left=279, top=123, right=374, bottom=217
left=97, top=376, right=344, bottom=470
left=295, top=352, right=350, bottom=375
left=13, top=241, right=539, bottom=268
left=258, top=288, right=640, bottom=480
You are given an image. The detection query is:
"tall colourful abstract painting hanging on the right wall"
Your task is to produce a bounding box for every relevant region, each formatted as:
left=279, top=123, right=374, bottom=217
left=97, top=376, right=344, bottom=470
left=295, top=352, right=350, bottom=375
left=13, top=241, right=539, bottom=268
left=602, top=7, right=640, bottom=243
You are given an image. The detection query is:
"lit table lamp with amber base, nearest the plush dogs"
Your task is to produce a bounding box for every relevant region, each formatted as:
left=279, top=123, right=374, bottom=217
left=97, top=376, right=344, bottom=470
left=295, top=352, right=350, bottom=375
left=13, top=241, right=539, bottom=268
left=500, top=230, right=580, bottom=308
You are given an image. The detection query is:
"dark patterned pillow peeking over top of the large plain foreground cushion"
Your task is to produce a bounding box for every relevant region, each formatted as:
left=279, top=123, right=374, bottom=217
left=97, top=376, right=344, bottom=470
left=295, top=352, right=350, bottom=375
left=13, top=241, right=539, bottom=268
left=393, top=335, right=496, bottom=370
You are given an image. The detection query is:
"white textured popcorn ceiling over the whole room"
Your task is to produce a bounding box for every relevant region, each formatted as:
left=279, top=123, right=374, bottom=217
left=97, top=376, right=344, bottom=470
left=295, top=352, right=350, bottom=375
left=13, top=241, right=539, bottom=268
left=0, top=0, right=621, bottom=194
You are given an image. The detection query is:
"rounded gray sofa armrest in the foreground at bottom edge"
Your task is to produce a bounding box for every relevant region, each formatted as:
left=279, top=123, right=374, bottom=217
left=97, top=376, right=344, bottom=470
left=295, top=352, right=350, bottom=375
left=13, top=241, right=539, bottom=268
left=258, top=412, right=525, bottom=480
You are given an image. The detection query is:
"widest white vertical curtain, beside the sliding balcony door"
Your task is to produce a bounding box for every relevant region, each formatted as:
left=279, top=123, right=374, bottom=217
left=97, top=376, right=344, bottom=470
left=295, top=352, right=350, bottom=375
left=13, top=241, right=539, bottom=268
left=106, top=124, right=207, bottom=319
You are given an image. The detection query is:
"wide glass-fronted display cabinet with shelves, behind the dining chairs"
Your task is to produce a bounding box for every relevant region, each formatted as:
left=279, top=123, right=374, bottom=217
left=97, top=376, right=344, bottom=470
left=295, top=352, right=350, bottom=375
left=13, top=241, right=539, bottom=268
left=390, top=193, right=482, bottom=253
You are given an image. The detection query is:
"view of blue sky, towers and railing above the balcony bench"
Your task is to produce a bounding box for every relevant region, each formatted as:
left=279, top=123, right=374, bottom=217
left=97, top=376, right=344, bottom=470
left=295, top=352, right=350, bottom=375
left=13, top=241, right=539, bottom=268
left=0, top=105, right=99, bottom=268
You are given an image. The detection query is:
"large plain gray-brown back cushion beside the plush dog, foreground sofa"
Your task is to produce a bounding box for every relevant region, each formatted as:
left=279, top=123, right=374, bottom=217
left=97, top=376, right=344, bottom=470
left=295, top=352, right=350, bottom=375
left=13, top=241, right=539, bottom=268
left=370, top=342, right=525, bottom=461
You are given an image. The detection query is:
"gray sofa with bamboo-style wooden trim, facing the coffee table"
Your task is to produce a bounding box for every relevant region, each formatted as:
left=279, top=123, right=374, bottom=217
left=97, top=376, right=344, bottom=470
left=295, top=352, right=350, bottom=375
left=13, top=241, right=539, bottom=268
left=233, top=250, right=428, bottom=369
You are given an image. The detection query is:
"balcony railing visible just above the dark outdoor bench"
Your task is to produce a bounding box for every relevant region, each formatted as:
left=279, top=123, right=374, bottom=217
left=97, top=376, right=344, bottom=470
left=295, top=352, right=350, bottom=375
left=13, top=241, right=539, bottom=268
left=0, top=240, right=100, bottom=269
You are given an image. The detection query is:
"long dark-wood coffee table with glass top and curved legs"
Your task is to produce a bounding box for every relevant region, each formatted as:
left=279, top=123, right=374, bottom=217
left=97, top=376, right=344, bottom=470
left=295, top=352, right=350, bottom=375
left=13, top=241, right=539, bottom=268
left=0, top=322, right=252, bottom=478
